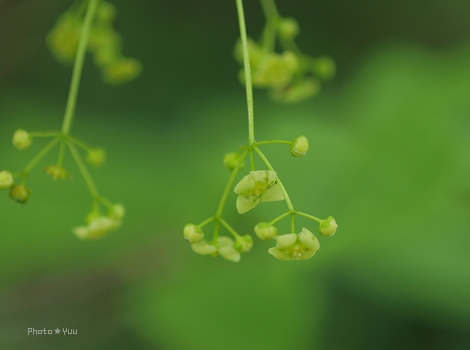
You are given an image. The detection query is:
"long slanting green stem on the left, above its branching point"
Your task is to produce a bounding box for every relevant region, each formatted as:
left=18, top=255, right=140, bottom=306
left=62, top=0, right=99, bottom=135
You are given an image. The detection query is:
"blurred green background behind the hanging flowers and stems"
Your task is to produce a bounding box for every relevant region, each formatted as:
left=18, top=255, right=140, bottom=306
left=0, top=0, right=470, bottom=350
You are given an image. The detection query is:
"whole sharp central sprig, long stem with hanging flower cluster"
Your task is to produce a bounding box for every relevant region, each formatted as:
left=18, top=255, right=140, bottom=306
left=184, top=0, right=338, bottom=262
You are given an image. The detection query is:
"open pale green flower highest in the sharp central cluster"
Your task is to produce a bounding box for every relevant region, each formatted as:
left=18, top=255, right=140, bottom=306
left=234, top=170, right=284, bottom=214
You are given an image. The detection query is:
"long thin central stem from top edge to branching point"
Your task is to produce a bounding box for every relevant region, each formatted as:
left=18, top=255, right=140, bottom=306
left=236, top=0, right=255, bottom=145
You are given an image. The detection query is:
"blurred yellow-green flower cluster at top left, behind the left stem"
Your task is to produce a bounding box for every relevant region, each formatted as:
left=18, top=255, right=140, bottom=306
left=47, top=1, right=142, bottom=85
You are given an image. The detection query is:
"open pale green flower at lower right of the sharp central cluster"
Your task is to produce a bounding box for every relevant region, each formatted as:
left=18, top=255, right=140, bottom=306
left=268, top=228, right=320, bottom=260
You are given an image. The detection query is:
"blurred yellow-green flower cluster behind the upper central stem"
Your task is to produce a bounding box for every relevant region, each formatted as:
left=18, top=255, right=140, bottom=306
left=235, top=18, right=335, bottom=103
